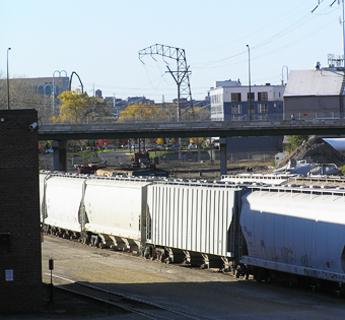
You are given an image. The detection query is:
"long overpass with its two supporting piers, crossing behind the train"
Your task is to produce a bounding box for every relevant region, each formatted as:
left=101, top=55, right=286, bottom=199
left=38, top=119, right=345, bottom=174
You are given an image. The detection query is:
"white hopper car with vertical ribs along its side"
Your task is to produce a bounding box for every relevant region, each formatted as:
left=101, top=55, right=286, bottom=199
left=145, top=181, right=243, bottom=267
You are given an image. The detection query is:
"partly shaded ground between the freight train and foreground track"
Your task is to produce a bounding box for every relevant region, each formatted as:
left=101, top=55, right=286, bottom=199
left=42, top=237, right=345, bottom=320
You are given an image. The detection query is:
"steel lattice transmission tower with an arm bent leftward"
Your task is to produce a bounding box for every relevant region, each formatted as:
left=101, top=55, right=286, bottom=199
left=139, top=44, right=194, bottom=122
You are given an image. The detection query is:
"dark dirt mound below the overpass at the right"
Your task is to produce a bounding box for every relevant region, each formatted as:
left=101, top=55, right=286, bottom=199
left=277, top=138, right=345, bottom=168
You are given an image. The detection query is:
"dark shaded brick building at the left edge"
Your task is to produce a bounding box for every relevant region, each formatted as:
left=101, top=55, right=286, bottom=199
left=0, top=110, right=43, bottom=314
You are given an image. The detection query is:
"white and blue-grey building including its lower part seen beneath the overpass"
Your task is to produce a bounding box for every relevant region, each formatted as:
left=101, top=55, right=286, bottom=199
left=210, top=80, right=285, bottom=160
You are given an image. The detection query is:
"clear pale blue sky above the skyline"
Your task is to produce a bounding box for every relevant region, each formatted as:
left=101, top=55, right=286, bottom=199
left=0, top=0, right=343, bottom=102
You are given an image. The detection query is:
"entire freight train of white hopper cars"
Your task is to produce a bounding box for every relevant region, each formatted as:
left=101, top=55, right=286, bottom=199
left=40, top=172, right=345, bottom=288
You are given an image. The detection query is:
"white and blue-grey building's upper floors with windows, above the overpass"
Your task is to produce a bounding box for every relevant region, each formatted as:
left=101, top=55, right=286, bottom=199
left=210, top=79, right=285, bottom=121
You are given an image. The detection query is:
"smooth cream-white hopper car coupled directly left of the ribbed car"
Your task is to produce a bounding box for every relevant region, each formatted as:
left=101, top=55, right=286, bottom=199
left=83, top=177, right=151, bottom=251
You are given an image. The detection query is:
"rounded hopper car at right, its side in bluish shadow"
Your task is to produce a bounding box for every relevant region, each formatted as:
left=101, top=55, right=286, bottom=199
left=240, top=187, right=345, bottom=283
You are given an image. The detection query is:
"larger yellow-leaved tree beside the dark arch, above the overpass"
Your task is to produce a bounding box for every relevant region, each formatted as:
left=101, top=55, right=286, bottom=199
left=52, top=90, right=110, bottom=124
